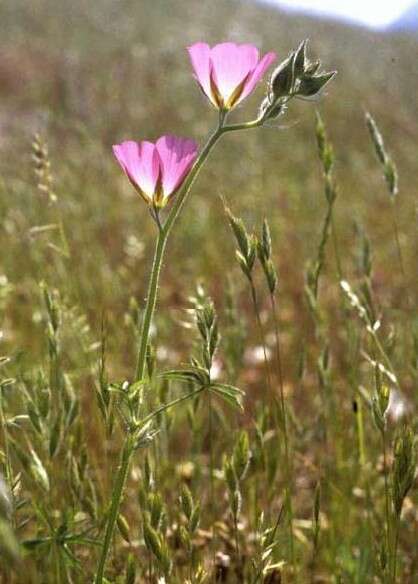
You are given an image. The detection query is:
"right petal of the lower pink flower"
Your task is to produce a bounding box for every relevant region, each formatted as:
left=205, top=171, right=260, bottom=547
left=156, top=136, right=198, bottom=197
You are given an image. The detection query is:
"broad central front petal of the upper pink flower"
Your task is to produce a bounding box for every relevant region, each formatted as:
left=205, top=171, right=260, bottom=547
left=210, top=43, right=258, bottom=104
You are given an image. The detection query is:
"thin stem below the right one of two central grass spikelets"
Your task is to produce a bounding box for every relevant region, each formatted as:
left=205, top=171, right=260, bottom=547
left=270, top=294, right=296, bottom=574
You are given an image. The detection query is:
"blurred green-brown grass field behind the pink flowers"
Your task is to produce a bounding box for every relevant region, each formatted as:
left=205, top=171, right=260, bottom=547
left=0, top=0, right=418, bottom=584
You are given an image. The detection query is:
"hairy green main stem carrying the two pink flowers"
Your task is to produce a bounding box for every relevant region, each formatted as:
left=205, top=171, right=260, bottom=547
left=95, top=112, right=263, bottom=584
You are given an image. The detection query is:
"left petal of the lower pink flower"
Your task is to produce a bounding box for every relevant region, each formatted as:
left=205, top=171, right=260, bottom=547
left=113, top=140, right=160, bottom=198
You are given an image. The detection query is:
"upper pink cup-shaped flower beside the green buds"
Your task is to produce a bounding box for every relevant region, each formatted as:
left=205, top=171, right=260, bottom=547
left=187, top=43, right=276, bottom=110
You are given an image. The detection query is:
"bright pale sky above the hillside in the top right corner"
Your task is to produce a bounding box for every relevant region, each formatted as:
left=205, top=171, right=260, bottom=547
left=270, top=0, right=416, bottom=27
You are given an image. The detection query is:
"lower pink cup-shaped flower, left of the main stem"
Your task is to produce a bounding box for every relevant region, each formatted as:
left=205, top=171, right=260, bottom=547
left=113, top=136, right=198, bottom=208
